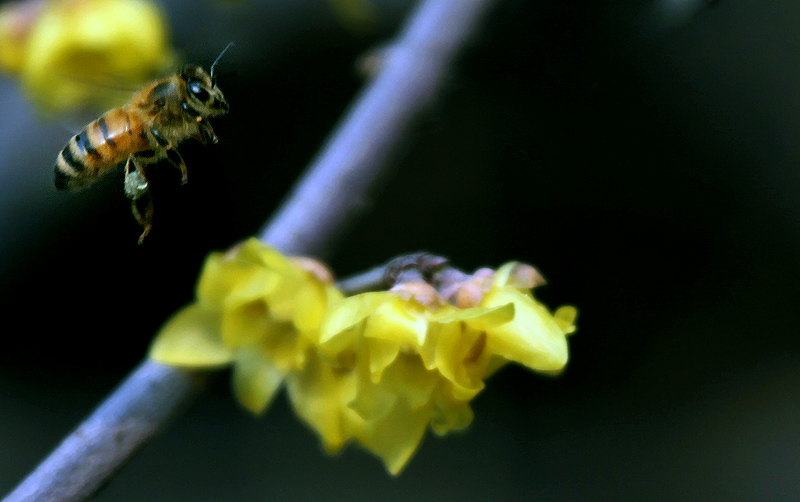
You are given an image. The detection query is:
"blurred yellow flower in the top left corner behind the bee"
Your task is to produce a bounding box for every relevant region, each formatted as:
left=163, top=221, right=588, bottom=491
left=0, top=0, right=173, bottom=111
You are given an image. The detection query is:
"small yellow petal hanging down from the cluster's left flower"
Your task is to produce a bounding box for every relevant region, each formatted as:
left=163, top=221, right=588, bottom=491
left=233, top=348, right=284, bottom=414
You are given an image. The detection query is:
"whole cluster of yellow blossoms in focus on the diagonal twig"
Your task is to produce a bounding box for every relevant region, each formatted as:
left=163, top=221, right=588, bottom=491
left=151, top=240, right=577, bottom=474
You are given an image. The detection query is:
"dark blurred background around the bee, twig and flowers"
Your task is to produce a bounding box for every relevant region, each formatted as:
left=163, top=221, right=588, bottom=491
left=0, top=0, right=800, bottom=502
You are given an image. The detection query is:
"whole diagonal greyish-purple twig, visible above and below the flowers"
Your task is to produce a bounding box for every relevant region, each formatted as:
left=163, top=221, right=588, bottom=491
left=4, top=0, right=491, bottom=502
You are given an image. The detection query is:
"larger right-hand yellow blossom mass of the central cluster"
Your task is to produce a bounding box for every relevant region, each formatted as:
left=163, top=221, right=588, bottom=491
left=287, top=263, right=577, bottom=474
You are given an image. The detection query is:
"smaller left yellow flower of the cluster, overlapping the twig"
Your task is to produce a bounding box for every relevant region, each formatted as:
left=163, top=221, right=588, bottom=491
left=150, top=239, right=341, bottom=413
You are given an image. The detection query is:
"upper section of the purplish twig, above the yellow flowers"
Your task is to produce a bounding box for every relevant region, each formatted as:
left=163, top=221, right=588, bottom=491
left=261, top=0, right=491, bottom=257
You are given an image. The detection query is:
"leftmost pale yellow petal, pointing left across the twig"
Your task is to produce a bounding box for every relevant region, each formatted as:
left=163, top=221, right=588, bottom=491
left=149, top=304, right=233, bottom=367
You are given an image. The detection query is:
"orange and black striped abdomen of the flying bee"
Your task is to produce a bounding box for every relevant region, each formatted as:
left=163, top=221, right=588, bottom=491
left=55, top=107, right=150, bottom=190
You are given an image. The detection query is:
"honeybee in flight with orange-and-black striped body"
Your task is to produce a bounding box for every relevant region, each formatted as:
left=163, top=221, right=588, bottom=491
left=55, top=44, right=231, bottom=244
